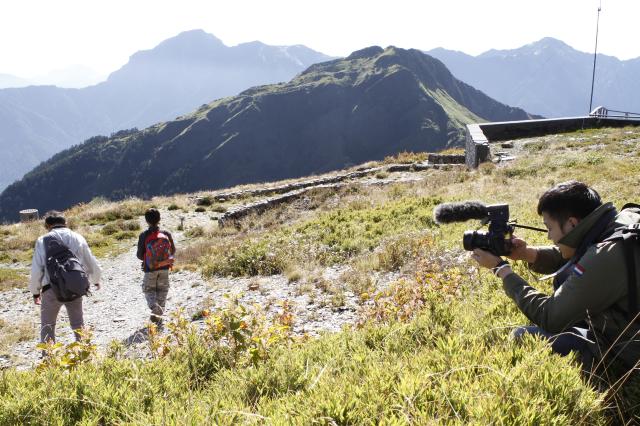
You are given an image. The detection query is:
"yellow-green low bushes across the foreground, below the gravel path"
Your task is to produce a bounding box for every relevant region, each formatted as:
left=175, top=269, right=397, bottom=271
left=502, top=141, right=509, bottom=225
left=0, top=276, right=610, bottom=424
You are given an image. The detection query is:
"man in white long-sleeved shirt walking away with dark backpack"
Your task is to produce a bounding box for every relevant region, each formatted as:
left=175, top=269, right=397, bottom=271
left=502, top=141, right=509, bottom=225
left=29, top=211, right=102, bottom=343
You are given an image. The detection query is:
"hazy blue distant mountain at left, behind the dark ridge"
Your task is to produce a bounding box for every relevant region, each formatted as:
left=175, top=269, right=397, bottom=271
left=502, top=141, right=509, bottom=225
left=0, top=30, right=330, bottom=190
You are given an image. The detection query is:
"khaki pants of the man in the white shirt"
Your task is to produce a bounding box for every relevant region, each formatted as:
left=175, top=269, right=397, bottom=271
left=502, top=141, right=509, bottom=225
left=40, top=289, right=84, bottom=343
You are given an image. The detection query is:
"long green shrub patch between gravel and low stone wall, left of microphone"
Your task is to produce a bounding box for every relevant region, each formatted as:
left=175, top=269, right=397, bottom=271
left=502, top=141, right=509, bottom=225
left=200, top=198, right=439, bottom=276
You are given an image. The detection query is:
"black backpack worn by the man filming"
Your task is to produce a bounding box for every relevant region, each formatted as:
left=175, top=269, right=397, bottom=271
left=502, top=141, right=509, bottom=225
left=603, top=203, right=640, bottom=322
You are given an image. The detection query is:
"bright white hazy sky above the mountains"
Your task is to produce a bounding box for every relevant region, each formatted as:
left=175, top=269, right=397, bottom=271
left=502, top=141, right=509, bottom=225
left=0, top=0, right=640, bottom=82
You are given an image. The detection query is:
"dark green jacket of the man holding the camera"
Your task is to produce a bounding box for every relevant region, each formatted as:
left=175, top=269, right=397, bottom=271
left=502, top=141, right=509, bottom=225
left=503, top=203, right=640, bottom=367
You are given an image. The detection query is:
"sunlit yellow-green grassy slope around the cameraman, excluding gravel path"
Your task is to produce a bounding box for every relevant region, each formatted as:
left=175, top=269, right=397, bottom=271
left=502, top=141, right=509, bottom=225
left=0, top=129, right=640, bottom=424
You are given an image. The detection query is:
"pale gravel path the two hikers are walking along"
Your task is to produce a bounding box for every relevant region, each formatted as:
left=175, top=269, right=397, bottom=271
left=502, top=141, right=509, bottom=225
left=0, top=169, right=436, bottom=369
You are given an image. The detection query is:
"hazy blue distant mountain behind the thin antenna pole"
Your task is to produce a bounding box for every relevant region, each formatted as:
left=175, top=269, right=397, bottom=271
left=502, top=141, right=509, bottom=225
left=426, top=37, right=640, bottom=117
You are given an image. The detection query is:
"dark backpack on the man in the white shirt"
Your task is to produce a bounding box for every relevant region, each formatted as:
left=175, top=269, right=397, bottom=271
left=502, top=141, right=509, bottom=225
left=43, top=234, right=90, bottom=302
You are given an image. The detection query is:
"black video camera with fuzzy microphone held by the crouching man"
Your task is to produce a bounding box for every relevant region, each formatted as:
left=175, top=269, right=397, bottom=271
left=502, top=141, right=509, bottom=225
left=433, top=201, right=547, bottom=256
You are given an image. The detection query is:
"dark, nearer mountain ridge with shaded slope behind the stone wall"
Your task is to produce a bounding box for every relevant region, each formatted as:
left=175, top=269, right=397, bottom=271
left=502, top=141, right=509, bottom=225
left=0, top=46, right=531, bottom=218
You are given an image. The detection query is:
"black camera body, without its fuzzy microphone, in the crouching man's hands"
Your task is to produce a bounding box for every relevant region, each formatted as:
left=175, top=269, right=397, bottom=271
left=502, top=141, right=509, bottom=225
left=462, top=204, right=514, bottom=256
